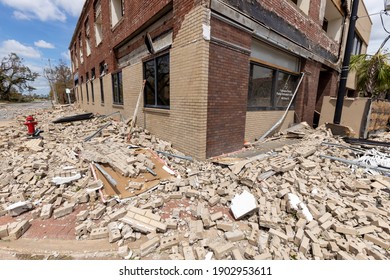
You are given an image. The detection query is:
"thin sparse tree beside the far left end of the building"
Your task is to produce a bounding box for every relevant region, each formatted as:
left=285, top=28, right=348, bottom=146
left=44, top=60, right=74, bottom=104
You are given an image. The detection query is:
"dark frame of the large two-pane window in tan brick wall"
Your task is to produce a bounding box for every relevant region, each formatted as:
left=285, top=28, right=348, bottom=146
left=142, top=51, right=171, bottom=110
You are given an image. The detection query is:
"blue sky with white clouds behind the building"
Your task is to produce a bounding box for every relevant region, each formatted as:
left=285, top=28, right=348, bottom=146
left=0, top=0, right=390, bottom=94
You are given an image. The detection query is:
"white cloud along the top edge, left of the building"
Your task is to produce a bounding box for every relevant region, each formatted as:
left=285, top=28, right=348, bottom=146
left=0, top=0, right=85, bottom=22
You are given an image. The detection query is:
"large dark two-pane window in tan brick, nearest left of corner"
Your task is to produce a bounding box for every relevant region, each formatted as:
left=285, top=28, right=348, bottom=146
left=144, top=54, right=170, bottom=109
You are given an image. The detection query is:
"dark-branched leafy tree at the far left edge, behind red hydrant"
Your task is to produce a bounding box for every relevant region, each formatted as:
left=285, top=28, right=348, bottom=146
left=0, top=53, right=39, bottom=101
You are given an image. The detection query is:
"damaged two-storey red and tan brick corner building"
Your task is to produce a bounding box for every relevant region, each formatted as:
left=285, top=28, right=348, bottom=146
left=69, top=0, right=371, bottom=158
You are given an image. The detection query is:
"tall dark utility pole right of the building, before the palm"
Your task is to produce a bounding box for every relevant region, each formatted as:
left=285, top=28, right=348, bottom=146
left=333, top=0, right=359, bottom=124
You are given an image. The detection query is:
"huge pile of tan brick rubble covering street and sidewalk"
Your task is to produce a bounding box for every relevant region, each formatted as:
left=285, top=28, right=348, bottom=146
left=0, top=105, right=390, bottom=260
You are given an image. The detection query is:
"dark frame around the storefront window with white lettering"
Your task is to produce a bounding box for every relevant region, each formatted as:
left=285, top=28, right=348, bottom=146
left=247, top=60, right=299, bottom=111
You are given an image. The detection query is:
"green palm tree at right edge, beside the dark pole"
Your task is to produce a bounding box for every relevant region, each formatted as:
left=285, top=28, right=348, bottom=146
left=350, top=36, right=390, bottom=99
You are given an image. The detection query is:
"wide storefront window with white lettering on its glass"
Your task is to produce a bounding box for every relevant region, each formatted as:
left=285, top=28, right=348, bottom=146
left=248, top=62, right=299, bottom=111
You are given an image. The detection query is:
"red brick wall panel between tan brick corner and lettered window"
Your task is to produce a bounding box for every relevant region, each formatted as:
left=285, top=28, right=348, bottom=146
left=206, top=18, right=251, bottom=157
